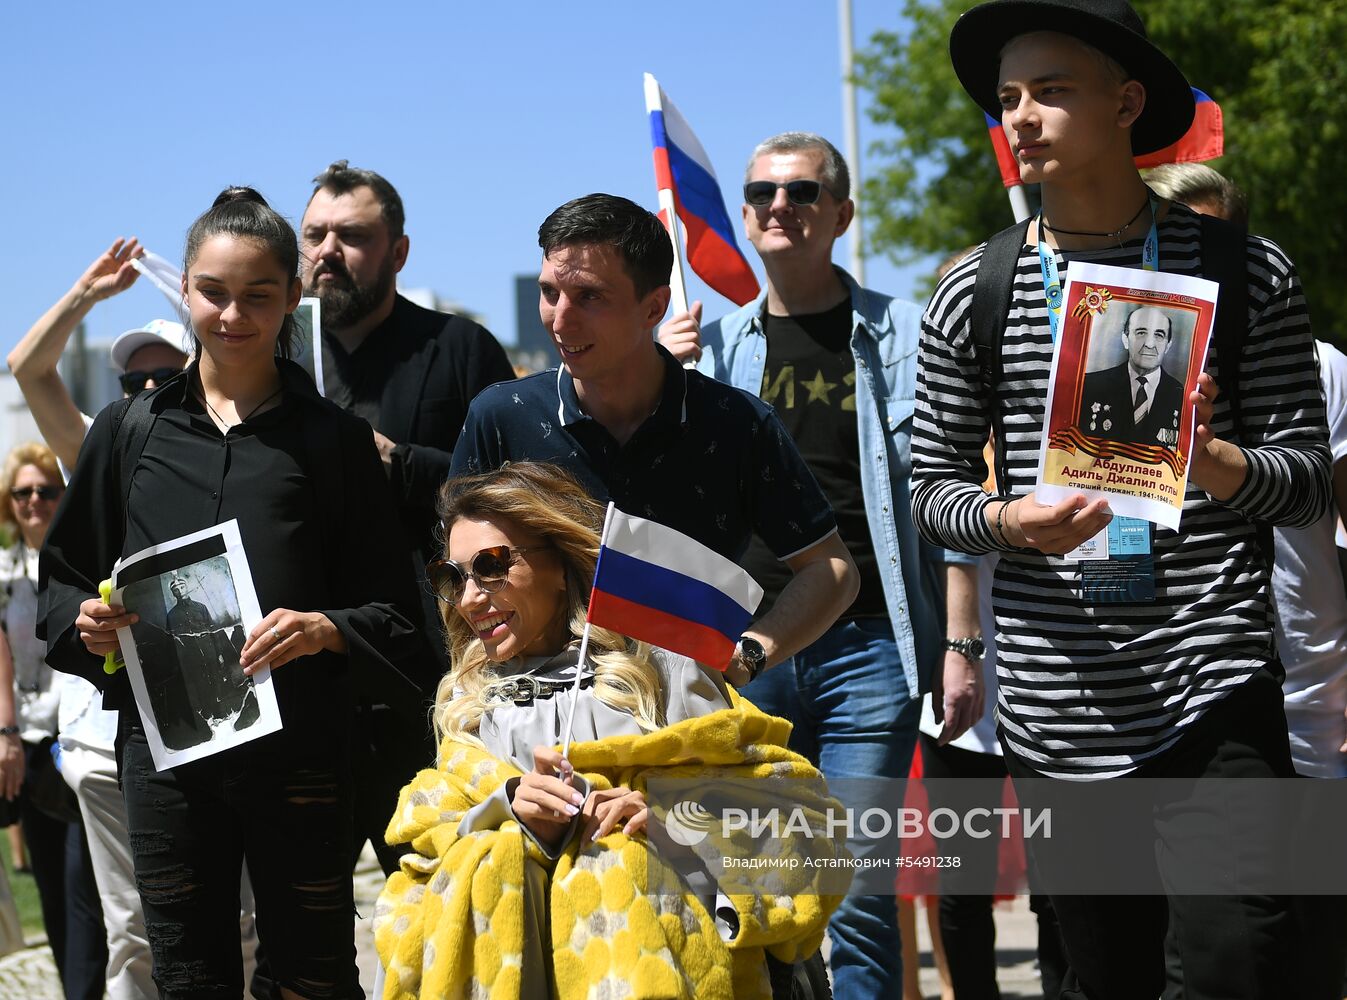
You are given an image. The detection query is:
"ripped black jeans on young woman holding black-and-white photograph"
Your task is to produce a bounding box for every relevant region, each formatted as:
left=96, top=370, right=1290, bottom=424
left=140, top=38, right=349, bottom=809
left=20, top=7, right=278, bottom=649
left=121, top=726, right=365, bottom=1000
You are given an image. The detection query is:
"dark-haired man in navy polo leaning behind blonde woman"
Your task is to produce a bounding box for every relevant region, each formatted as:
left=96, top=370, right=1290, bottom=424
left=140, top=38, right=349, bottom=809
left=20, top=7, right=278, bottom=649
left=451, top=194, right=858, bottom=686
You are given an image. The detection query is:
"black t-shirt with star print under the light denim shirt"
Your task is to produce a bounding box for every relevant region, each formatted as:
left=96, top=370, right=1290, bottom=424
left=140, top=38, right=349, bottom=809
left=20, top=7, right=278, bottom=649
left=742, top=298, right=889, bottom=620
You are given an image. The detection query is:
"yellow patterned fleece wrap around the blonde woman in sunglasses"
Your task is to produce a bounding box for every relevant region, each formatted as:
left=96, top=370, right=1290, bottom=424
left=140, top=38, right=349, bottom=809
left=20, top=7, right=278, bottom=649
left=374, top=694, right=842, bottom=1000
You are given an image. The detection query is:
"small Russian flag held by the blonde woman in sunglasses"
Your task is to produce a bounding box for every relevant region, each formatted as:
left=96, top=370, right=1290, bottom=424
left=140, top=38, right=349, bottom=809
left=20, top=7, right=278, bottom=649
left=586, top=504, right=762, bottom=670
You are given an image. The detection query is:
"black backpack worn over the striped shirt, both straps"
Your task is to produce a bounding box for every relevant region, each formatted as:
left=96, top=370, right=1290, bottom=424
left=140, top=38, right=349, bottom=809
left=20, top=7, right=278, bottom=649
left=970, top=216, right=1273, bottom=571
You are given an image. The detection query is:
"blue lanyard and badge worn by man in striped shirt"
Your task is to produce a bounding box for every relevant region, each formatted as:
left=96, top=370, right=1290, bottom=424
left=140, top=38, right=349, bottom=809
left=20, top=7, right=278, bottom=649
left=1039, top=195, right=1160, bottom=604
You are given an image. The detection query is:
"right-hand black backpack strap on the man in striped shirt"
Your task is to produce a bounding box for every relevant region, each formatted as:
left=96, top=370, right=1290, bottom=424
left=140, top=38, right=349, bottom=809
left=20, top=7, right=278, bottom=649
left=1202, top=216, right=1276, bottom=573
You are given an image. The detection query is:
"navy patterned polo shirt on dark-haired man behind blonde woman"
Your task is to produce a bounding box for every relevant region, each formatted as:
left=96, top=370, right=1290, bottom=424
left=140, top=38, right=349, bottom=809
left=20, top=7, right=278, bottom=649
left=453, top=348, right=835, bottom=559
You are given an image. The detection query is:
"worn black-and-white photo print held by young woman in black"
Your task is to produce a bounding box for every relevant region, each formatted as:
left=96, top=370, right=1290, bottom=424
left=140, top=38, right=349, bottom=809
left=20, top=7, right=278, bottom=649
left=113, top=522, right=280, bottom=770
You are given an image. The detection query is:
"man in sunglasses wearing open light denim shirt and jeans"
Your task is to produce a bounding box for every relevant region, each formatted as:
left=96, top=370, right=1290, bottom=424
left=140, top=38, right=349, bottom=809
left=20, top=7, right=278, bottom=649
left=660, top=132, right=983, bottom=999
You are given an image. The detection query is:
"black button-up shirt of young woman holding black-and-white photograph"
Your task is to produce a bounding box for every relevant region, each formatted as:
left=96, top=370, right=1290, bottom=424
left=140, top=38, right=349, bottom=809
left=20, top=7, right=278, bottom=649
left=38, top=363, right=436, bottom=737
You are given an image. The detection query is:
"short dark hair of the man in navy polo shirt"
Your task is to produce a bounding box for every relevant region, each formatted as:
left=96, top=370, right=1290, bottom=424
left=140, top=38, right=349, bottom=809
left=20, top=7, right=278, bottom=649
left=537, top=194, right=674, bottom=298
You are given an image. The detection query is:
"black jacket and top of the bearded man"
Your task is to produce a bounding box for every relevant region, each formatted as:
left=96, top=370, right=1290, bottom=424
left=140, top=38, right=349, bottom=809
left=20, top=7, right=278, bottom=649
left=323, top=295, right=515, bottom=651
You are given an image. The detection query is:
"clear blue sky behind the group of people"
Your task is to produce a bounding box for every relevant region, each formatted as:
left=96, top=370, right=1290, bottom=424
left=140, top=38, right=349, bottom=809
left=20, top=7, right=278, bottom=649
left=0, top=0, right=924, bottom=350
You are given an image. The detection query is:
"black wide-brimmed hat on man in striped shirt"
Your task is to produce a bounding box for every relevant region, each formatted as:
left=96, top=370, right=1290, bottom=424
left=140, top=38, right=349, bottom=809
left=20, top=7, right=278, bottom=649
left=950, top=0, right=1193, bottom=156
